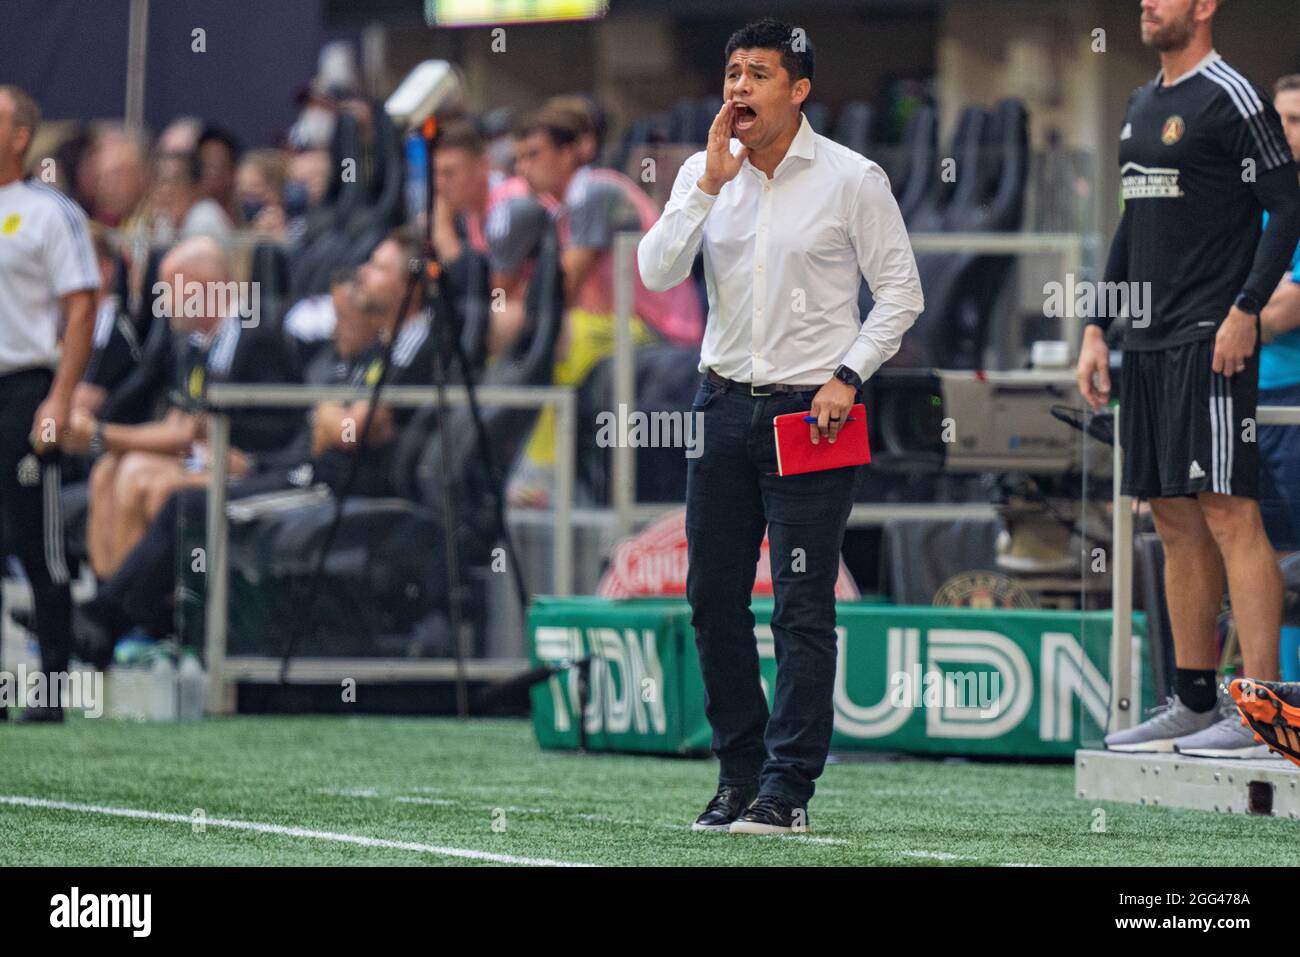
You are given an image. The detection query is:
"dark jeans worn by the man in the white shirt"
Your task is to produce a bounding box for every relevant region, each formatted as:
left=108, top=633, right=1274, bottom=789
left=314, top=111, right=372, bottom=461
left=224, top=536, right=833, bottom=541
left=686, top=380, right=858, bottom=805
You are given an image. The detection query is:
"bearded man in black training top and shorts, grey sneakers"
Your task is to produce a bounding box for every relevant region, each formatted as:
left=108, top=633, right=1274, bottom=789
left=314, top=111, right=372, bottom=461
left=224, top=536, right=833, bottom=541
left=1079, top=0, right=1300, bottom=758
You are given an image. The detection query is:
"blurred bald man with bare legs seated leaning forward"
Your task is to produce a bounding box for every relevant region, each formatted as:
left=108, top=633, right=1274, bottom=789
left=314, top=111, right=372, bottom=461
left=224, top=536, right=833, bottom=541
left=66, top=238, right=299, bottom=579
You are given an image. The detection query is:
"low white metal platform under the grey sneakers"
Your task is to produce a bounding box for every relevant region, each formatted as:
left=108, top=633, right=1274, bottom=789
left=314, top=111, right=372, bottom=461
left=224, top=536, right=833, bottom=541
left=1074, top=750, right=1300, bottom=820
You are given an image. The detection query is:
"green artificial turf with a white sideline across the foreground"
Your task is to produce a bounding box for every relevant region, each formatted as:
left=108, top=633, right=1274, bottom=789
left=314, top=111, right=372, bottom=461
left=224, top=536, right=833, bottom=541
left=0, top=716, right=1300, bottom=866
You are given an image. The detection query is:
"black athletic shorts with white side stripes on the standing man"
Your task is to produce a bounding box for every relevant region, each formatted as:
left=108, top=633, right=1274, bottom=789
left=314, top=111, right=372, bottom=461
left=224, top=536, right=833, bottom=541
left=1119, top=330, right=1260, bottom=499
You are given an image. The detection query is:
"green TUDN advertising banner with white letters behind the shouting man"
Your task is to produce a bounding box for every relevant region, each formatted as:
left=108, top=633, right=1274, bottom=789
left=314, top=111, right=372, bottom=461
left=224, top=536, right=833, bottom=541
left=528, top=597, right=1152, bottom=758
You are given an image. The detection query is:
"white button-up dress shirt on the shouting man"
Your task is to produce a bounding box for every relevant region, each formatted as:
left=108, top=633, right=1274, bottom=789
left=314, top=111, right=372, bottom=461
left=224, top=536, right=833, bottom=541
left=637, top=113, right=924, bottom=385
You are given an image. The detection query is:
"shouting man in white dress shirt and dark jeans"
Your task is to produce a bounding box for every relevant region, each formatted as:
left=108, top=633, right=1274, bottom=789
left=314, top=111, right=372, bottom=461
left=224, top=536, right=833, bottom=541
left=637, top=20, right=923, bottom=833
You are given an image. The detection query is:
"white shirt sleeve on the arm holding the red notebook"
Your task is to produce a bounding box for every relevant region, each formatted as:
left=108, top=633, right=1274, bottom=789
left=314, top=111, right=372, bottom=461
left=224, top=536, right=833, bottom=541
left=842, top=168, right=926, bottom=381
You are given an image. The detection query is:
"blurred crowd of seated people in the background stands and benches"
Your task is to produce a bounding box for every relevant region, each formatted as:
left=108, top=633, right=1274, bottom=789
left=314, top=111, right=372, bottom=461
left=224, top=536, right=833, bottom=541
left=20, top=50, right=705, bottom=664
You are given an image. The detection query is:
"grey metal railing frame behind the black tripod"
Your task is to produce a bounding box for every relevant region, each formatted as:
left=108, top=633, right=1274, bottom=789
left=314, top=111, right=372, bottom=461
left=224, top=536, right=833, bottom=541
left=204, top=382, right=577, bottom=714
